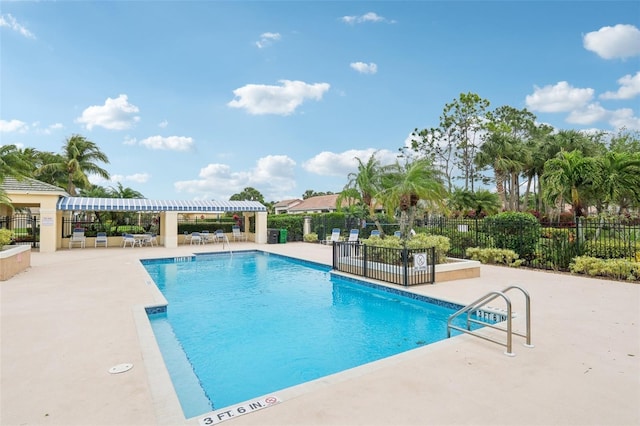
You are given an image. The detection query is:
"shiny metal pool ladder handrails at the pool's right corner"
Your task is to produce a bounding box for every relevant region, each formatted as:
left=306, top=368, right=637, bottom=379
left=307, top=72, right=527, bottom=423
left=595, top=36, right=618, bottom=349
left=447, top=285, right=534, bottom=356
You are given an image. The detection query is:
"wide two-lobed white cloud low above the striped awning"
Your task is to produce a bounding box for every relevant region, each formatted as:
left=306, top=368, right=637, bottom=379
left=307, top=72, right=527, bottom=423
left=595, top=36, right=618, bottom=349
left=174, top=155, right=296, bottom=200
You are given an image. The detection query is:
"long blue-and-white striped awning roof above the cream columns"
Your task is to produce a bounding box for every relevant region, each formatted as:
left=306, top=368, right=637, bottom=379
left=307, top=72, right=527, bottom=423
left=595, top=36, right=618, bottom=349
left=57, top=197, right=267, bottom=212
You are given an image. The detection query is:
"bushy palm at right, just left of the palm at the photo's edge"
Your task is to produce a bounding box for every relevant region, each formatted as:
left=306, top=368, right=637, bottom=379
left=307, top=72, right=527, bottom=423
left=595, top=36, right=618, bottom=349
left=542, top=150, right=600, bottom=217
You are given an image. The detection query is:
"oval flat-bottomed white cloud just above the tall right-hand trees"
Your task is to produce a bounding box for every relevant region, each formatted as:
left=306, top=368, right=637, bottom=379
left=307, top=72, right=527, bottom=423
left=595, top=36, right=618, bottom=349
left=525, top=81, right=594, bottom=112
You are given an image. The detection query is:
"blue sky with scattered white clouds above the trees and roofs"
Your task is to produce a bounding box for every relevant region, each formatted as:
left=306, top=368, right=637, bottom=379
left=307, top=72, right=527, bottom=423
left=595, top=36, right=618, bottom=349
left=0, top=1, right=640, bottom=201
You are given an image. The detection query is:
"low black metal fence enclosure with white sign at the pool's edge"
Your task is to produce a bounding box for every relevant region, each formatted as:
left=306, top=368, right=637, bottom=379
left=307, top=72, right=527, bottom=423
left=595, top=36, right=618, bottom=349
left=333, top=242, right=436, bottom=286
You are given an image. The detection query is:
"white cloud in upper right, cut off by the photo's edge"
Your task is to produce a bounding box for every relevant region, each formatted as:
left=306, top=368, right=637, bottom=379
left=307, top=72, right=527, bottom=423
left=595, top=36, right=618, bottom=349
left=582, top=24, right=640, bottom=59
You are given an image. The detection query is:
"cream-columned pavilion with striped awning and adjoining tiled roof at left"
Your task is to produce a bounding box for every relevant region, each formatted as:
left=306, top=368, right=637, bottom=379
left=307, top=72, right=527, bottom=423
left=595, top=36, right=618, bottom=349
left=0, top=177, right=267, bottom=252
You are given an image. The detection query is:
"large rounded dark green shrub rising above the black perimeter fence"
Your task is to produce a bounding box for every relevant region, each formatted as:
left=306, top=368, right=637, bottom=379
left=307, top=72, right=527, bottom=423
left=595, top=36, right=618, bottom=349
left=484, top=212, right=540, bottom=259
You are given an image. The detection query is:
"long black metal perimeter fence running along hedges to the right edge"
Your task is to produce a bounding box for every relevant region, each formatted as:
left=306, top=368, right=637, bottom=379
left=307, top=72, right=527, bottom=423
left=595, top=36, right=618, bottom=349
left=417, top=218, right=640, bottom=271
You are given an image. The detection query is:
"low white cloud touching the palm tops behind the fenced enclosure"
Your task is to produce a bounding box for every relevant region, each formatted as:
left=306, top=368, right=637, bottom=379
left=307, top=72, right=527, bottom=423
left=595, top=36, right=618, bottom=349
left=302, top=148, right=397, bottom=177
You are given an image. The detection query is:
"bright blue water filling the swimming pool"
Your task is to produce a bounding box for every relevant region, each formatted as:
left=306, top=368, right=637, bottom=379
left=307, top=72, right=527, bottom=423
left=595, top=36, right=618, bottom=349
left=143, top=252, right=480, bottom=417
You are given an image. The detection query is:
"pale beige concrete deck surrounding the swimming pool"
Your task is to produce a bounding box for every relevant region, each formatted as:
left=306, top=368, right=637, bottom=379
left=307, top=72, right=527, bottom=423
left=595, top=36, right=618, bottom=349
left=0, top=243, right=640, bottom=426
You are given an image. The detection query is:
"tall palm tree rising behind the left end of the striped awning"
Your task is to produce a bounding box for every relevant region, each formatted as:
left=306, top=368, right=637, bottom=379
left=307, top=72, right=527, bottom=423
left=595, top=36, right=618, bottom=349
left=37, top=135, right=110, bottom=195
